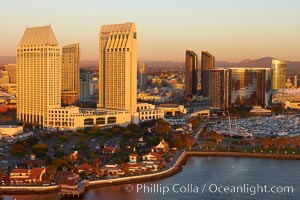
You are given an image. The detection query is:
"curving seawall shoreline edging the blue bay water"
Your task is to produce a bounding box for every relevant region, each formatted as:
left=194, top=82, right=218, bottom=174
left=0, top=151, right=300, bottom=195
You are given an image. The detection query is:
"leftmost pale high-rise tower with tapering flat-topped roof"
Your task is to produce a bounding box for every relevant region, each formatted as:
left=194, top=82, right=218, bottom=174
left=17, top=26, right=61, bottom=127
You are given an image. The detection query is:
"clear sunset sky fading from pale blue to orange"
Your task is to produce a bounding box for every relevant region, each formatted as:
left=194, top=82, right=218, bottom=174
left=0, top=0, right=300, bottom=62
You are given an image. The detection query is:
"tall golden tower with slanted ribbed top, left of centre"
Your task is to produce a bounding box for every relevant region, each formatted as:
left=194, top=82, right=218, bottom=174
left=98, top=22, right=137, bottom=114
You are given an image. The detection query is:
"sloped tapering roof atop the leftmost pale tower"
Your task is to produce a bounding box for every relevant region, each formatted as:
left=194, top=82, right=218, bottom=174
left=19, top=26, right=59, bottom=47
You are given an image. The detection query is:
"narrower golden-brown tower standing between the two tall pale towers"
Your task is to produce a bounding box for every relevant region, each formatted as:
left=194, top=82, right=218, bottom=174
left=61, top=43, right=80, bottom=104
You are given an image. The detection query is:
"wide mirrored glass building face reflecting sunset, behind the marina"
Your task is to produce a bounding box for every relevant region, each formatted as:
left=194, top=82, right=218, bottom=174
left=228, top=68, right=272, bottom=106
